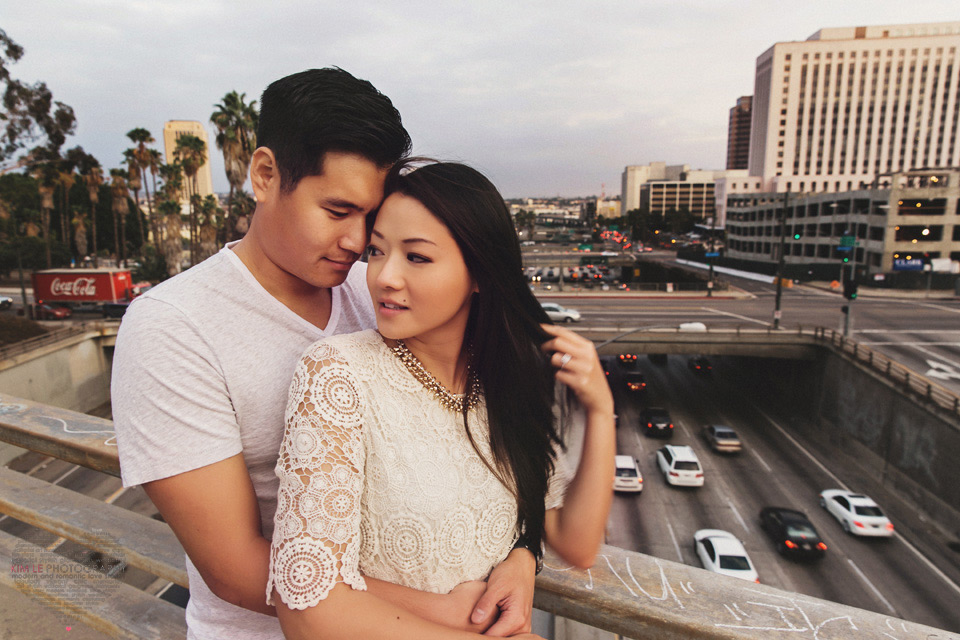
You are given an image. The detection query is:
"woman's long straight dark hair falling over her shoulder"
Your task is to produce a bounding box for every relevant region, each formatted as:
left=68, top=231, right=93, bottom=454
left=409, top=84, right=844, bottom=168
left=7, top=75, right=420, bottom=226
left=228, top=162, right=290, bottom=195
left=387, top=162, right=560, bottom=550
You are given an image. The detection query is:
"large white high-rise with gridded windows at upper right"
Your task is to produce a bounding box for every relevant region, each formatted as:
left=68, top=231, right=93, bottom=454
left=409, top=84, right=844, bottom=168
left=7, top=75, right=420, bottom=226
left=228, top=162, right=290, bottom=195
left=749, top=22, right=960, bottom=192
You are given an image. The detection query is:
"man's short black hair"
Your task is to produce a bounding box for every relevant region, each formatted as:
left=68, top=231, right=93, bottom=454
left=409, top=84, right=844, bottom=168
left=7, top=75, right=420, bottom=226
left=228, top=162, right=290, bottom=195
left=257, top=68, right=411, bottom=193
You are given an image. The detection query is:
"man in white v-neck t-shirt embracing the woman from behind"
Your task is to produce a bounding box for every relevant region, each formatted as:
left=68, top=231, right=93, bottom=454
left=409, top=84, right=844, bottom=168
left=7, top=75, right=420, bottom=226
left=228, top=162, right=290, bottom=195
left=111, top=69, right=534, bottom=639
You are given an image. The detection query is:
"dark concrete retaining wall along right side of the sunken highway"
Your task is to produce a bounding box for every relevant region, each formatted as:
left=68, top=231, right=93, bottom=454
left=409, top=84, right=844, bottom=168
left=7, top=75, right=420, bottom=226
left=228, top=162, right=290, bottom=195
left=731, top=351, right=960, bottom=532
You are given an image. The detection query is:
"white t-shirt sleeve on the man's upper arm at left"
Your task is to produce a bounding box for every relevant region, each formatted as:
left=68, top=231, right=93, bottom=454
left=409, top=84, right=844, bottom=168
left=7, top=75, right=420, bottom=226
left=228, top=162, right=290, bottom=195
left=110, top=298, right=242, bottom=486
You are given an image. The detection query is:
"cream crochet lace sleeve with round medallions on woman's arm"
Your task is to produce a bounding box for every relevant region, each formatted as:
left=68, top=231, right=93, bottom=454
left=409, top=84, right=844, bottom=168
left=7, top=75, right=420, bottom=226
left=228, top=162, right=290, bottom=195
left=267, top=344, right=366, bottom=609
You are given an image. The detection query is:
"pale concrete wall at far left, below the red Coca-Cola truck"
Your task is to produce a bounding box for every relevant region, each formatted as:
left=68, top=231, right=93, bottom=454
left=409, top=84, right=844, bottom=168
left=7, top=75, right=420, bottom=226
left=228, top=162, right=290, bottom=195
left=0, top=333, right=113, bottom=413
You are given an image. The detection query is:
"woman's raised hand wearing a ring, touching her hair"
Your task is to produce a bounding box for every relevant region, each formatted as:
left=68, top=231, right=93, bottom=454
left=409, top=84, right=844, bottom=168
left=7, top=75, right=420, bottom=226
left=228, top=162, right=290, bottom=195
left=540, top=324, right=613, bottom=416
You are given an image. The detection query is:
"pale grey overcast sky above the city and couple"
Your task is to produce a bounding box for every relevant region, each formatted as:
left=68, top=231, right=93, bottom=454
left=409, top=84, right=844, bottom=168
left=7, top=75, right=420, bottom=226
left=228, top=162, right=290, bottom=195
left=0, top=0, right=960, bottom=198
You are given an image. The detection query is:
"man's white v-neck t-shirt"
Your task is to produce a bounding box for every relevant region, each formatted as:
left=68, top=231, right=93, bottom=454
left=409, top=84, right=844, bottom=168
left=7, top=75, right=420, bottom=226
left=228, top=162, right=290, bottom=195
left=111, top=245, right=376, bottom=640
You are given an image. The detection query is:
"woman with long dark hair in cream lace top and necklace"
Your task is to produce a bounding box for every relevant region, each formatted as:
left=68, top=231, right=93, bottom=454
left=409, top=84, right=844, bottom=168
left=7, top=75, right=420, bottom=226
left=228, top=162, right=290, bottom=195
left=267, top=163, right=615, bottom=638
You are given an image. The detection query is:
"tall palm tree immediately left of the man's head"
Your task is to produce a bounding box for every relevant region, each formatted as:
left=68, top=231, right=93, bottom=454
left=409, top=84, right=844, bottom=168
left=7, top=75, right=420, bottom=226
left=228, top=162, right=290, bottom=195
left=210, top=91, right=260, bottom=242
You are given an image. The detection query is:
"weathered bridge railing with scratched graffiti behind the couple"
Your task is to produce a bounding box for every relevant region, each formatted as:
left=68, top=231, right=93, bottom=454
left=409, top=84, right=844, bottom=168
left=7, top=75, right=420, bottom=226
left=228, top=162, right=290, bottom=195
left=0, top=395, right=956, bottom=640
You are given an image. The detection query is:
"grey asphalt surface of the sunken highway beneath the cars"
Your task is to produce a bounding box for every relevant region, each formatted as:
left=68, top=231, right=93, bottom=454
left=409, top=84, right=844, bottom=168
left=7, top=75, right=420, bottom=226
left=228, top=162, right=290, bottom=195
left=608, top=356, right=960, bottom=631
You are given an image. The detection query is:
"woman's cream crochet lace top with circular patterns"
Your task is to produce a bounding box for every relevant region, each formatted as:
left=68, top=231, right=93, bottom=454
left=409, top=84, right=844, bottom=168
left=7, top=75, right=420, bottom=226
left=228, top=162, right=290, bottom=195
left=267, top=331, right=568, bottom=609
